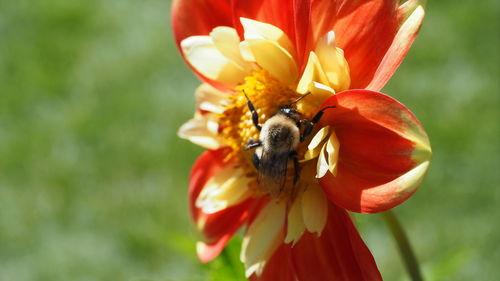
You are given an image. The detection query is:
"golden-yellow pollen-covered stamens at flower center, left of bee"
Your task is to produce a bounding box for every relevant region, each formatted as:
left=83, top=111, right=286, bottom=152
left=219, top=69, right=311, bottom=198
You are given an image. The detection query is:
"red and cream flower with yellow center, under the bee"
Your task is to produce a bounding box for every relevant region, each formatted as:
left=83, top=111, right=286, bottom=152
left=172, top=0, right=431, bottom=280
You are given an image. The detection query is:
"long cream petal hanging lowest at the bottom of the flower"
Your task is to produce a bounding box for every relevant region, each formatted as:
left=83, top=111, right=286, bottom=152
left=240, top=202, right=286, bottom=277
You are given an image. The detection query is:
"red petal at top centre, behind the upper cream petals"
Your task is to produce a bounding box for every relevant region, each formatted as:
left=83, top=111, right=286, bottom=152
left=233, top=0, right=311, bottom=69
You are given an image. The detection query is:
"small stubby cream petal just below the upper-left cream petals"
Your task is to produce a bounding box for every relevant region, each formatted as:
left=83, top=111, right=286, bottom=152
left=195, top=83, right=229, bottom=113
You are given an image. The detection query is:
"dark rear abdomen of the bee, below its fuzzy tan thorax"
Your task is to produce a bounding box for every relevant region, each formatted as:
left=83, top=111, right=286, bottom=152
left=258, top=147, right=289, bottom=197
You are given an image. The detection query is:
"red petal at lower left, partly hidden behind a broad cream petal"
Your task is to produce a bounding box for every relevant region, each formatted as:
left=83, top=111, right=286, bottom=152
left=189, top=149, right=254, bottom=262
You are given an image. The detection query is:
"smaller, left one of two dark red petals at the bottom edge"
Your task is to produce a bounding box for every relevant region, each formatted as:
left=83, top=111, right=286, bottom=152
left=250, top=244, right=297, bottom=281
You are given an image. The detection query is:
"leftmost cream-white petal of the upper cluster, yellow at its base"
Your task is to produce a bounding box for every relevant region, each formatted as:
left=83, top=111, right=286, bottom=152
left=181, top=36, right=248, bottom=87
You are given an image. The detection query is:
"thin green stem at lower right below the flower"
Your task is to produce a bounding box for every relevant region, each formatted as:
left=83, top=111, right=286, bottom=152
left=382, top=211, right=424, bottom=281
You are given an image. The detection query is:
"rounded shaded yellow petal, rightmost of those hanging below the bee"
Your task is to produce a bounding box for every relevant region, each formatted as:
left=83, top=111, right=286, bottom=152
left=302, top=184, right=328, bottom=236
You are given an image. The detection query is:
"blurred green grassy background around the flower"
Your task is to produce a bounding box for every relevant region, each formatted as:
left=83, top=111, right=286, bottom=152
left=0, top=0, right=500, bottom=281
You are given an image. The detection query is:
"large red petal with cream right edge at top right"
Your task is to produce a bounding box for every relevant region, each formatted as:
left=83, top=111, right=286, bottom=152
left=311, top=0, right=423, bottom=91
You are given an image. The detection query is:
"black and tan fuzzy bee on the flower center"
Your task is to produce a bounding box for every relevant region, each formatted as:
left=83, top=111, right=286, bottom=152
left=243, top=93, right=335, bottom=197
